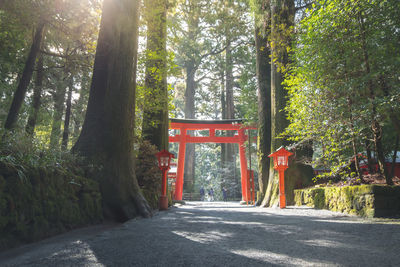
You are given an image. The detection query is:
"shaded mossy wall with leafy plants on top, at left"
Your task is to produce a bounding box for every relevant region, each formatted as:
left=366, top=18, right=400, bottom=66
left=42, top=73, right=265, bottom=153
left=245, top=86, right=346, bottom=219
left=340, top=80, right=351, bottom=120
left=0, top=132, right=102, bottom=250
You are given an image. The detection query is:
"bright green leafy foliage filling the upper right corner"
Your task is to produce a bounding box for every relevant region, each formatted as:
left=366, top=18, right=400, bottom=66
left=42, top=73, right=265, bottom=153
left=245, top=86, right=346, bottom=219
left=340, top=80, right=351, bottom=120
left=285, top=0, right=400, bottom=174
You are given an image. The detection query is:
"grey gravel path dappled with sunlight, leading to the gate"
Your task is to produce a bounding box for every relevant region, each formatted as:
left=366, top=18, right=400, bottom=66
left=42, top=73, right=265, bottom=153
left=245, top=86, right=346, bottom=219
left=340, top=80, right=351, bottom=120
left=0, top=202, right=400, bottom=266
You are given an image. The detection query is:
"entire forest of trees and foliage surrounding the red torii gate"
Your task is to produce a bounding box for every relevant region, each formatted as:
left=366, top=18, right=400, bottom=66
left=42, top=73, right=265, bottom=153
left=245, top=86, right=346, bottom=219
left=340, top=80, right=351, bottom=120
left=0, top=0, right=400, bottom=220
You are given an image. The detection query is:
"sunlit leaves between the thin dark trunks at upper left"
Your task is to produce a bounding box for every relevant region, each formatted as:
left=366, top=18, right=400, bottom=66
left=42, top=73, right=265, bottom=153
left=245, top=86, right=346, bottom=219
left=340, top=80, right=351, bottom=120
left=0, top=0, right=101, bottom=147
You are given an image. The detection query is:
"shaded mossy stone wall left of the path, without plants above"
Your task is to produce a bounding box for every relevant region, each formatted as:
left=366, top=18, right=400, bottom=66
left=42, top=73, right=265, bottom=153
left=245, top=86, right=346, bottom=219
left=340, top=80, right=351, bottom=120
left=0, top=162, right=103, bottom=250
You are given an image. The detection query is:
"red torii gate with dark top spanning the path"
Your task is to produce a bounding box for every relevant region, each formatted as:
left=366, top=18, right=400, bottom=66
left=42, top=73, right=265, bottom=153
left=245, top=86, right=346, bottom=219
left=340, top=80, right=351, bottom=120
left=169, top=119, right=257, bottom=201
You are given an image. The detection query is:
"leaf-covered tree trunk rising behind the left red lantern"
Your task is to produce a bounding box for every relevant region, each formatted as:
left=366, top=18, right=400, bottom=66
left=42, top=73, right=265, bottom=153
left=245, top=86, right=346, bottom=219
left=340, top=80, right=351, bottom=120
left=143, top=0, right=169, bottom=150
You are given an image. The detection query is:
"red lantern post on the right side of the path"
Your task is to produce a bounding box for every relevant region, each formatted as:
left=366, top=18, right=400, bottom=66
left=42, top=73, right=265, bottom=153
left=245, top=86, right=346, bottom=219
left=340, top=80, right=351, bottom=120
left=268, top=146, right=293, bottom=209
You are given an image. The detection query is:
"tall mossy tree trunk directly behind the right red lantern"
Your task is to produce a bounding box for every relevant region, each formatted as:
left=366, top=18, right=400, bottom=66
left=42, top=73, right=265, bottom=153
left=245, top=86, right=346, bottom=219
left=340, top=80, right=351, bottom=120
left=261, top=0, right=295, bottom=206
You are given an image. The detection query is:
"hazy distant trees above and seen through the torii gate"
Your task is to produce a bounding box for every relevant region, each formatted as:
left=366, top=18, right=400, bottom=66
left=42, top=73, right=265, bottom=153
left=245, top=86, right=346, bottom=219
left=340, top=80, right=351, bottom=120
left=169, top=0, right=256, bottom=193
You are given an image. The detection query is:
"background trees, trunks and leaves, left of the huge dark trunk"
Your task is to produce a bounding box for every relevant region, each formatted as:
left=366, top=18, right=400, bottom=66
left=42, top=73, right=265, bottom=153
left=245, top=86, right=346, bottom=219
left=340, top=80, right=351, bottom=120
left=0, top=0, right=99, bottom=149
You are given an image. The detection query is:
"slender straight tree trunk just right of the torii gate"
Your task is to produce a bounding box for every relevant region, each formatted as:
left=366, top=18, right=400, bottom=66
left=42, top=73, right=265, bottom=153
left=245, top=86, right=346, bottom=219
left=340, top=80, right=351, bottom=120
left=255, top=13, right=271, bottom=200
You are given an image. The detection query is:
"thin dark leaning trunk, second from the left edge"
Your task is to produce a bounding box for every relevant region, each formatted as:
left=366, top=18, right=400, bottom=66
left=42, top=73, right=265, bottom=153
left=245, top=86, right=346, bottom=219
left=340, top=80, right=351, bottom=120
left=25, top=54, right=44, bottom=136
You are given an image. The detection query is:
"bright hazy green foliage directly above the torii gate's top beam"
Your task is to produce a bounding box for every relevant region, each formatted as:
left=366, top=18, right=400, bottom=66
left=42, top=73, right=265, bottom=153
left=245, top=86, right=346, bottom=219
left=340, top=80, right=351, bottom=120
left=168, top=0, right=256, bottom=119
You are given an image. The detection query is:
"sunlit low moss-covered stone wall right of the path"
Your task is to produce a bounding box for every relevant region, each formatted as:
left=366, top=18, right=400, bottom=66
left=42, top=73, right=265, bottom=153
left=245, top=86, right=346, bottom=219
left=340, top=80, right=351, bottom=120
left=295, top=185, right=400, bottom=217
